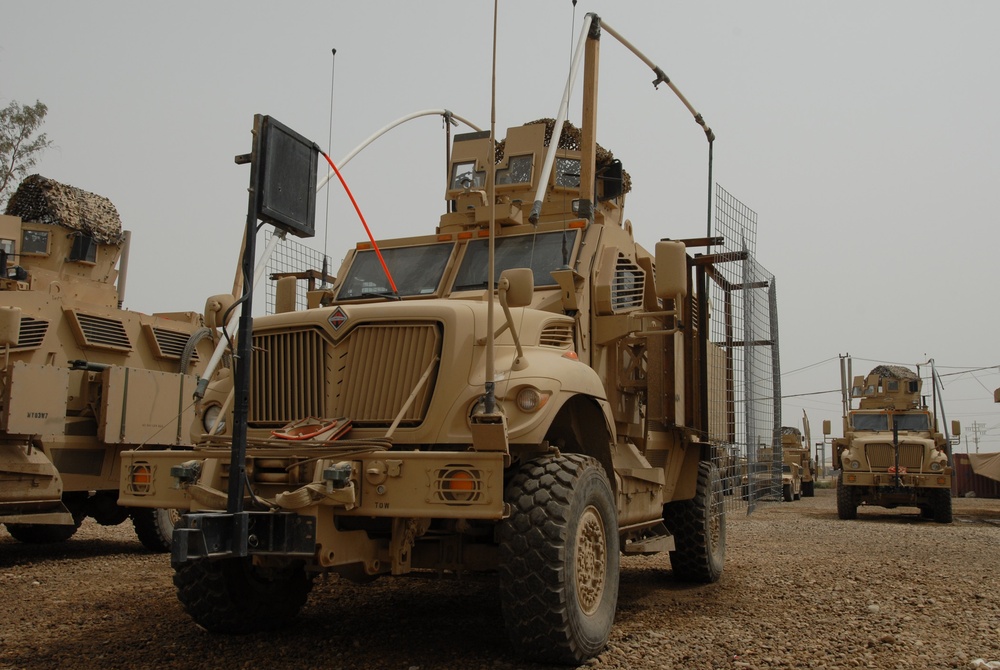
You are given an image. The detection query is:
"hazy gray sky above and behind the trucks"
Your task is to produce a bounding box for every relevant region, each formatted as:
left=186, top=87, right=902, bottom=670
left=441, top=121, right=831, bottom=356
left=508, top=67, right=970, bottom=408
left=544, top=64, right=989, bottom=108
left=0, top=0, right=1000, bottom=451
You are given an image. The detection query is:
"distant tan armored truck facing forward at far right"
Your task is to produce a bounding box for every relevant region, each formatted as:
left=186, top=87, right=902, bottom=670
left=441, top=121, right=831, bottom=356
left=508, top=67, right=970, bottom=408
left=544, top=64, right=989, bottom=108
left=824, top=358, right=960, bottom=523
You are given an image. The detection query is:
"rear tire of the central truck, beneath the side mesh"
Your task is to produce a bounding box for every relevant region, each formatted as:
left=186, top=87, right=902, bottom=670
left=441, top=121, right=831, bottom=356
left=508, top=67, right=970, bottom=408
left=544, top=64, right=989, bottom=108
left=663, top=461, right=726, bottom=584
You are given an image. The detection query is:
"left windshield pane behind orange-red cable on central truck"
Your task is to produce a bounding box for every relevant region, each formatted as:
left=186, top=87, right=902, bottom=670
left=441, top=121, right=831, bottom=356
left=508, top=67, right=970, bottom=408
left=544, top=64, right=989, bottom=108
left=337, top=242, right=454, bottom=300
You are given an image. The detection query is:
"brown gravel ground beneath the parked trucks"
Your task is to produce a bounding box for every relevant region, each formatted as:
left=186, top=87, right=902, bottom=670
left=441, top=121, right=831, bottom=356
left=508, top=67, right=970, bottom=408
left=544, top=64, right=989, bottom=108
left=0, top=490, right=1000, bottom=670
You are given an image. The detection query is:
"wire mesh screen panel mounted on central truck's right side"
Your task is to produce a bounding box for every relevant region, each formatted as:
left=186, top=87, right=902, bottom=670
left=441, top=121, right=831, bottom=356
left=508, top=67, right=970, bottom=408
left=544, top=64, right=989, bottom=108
left=709, top=185, right=782, bottom=510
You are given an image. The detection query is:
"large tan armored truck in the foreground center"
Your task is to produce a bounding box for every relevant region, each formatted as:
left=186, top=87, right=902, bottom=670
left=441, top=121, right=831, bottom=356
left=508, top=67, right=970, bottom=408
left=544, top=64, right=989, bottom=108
left=122, top=17, right=772, bottom=664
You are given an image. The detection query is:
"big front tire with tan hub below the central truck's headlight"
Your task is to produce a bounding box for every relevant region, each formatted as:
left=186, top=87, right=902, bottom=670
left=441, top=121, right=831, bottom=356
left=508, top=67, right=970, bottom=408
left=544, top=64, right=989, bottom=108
left=499, top=454, right=620, bottom=665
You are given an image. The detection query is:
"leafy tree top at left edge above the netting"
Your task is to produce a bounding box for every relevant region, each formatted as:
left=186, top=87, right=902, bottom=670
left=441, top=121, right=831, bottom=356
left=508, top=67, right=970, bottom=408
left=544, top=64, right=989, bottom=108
left=0, top=100, right=52, bottom=203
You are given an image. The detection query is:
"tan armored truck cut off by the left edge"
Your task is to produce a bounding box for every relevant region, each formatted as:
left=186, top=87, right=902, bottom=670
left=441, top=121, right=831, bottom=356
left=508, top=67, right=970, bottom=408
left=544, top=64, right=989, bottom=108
left=0, top=175, right=211, bottom=551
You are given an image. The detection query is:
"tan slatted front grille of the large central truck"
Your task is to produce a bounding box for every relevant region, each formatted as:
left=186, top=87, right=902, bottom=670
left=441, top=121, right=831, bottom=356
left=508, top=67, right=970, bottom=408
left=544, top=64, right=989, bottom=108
left=248, top=323, right=441, bottom=428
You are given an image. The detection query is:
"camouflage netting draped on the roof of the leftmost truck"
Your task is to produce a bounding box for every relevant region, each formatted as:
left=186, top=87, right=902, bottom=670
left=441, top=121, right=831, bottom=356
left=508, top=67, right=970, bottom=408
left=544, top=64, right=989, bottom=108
left=6, top=174, right=125, bottom=244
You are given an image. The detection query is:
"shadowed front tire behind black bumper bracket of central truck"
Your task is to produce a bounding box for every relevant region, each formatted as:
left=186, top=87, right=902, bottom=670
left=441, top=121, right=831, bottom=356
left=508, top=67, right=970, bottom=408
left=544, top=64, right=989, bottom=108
left=174, top=557, right=312, bottom=633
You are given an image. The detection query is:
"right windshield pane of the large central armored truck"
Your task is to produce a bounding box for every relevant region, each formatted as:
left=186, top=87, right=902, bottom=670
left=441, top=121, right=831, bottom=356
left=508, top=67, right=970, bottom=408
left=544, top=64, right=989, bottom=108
left=454, top=230, right=576, bottom=291
